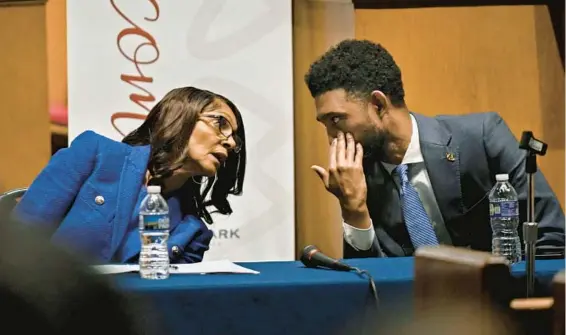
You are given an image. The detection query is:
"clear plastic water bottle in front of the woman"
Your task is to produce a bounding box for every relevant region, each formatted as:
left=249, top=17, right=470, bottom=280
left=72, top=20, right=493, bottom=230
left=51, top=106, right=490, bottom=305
left=139, top=186, right=169, bottom=279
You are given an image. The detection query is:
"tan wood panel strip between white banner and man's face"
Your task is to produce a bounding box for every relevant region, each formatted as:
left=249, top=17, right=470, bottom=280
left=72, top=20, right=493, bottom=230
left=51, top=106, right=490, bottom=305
left=293, top=0, right=354, bottom=257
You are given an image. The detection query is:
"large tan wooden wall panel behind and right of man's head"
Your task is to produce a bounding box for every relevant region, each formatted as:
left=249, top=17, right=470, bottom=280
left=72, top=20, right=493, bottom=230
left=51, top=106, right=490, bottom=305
left=356, top=6, right=565, bottom=207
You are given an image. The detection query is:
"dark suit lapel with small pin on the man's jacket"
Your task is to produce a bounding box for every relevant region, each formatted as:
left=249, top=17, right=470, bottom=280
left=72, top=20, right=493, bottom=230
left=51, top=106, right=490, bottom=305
left=412, top=113, right=464, bottom=223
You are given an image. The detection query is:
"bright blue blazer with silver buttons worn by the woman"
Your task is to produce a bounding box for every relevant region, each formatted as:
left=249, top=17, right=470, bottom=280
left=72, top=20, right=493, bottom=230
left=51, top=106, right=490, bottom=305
left=13, top=131, right=213, bottom=263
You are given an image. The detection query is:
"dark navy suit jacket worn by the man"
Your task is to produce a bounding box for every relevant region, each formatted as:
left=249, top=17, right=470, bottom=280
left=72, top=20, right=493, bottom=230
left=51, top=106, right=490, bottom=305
left=344, top=112, right=564, bottom=258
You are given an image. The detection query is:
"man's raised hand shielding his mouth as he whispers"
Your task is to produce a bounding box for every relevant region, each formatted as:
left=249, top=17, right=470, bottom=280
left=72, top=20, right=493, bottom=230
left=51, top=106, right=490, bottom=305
left=311, top=132, right=372, bottom=229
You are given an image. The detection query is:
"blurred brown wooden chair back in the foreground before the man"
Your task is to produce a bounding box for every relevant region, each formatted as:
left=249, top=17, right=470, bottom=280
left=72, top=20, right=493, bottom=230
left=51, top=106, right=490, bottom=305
left=414, top=246, right=516, bottom=335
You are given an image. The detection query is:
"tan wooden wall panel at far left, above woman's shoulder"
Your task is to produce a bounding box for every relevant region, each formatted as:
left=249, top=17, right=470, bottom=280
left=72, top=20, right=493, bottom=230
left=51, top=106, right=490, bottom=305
left=0, top=3, right=51, bottom=192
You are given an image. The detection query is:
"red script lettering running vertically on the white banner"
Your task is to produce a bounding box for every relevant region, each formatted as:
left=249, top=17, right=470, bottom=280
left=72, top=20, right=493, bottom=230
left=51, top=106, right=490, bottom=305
left=110, top=0, right=159, bottom=136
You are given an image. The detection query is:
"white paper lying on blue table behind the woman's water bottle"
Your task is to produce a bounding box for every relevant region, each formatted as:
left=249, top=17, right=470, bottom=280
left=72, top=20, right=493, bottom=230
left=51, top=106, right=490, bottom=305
left=92, top=260, right=259, bottom=274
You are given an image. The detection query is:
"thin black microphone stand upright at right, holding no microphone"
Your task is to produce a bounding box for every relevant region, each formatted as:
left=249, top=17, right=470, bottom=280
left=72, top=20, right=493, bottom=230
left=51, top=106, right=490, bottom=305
left=519, top=131, right=548, bottom=298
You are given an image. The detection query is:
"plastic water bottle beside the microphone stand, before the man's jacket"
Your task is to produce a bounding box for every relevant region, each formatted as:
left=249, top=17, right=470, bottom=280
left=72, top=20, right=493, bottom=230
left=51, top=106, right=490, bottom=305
left=489, top=174, right=522, bottom=263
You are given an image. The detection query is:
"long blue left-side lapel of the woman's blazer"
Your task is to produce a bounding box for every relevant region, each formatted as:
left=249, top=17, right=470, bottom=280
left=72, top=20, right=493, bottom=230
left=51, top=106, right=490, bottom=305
left=111, top=146, right=150, bottom=257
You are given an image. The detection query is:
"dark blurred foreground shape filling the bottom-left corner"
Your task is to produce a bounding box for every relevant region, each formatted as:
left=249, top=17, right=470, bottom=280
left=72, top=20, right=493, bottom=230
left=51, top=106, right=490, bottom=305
left=0, top=218, right=154, bottom=335
